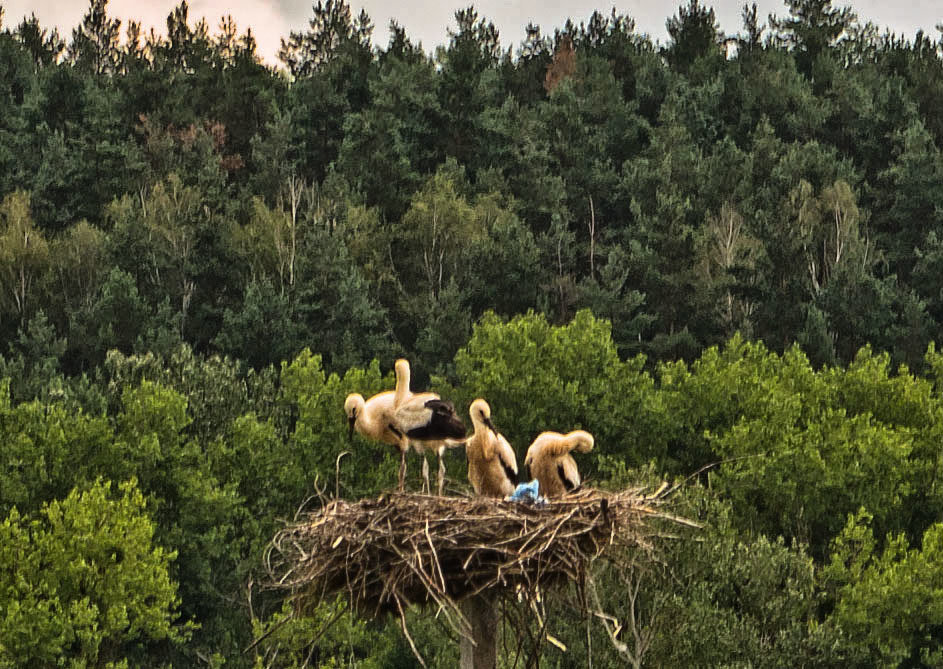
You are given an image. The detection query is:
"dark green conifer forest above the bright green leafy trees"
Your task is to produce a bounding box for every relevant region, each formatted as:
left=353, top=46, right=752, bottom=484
left=0, top=0, right=943, bottom=374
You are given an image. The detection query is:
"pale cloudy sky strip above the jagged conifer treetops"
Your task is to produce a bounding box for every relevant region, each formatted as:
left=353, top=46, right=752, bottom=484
left=0, top=0, right=943, bottom=63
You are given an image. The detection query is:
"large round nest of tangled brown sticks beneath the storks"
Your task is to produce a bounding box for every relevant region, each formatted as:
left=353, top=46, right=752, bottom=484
left=266, top=486, right=688, bottom=619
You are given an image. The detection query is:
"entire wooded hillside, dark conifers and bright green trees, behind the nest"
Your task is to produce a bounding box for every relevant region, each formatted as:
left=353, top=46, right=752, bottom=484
left=0, top=0, right=943, bottom=669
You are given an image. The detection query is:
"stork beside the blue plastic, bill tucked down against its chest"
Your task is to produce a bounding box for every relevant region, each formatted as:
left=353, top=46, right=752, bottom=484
left=465, top=399, right=517, bottom=497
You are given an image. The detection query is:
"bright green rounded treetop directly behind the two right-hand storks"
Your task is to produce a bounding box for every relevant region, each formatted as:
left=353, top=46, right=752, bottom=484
left=455, top=310, right=661, bottom=471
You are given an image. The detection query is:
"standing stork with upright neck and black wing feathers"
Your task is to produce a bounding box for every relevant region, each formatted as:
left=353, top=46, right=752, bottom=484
left=390, top=358, right=465, bottom=495
